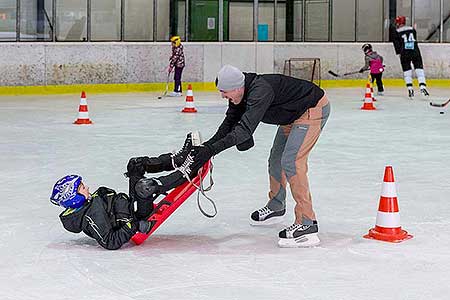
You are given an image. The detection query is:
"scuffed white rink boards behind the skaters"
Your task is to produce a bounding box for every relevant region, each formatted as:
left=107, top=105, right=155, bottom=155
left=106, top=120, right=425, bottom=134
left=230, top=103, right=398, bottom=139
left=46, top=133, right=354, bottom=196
left=0, top=42, right=450, bottom=86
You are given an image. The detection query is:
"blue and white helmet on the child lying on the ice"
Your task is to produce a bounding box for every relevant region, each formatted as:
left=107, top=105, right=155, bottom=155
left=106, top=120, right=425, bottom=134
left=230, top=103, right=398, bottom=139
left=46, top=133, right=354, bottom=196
left=50, top=175, right=86, bottom=208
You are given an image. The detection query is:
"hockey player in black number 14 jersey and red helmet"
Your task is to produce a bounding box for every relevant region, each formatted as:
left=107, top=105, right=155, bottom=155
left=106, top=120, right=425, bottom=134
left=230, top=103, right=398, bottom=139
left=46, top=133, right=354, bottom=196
left=393, top=16, right=429, bottom=98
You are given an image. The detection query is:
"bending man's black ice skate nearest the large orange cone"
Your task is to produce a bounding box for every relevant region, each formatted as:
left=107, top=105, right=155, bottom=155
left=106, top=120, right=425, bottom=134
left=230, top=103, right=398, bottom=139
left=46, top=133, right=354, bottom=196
left=278, top=221, right=320, bottom=248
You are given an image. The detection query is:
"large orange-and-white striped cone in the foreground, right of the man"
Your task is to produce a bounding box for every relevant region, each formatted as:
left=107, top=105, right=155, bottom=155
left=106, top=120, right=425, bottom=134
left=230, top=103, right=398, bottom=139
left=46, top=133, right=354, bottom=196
left=364, top=166, right=413, bottom=243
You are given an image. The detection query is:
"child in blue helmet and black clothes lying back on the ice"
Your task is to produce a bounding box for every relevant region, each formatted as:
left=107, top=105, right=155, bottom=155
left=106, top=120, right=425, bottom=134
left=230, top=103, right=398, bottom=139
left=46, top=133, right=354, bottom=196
left=50, top=133, right=198, bottom=250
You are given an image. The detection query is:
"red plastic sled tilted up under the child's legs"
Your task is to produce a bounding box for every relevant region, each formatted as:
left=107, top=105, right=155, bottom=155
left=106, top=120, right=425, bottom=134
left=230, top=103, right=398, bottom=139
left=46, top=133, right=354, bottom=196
left=131, top=160, right=211, bottom=245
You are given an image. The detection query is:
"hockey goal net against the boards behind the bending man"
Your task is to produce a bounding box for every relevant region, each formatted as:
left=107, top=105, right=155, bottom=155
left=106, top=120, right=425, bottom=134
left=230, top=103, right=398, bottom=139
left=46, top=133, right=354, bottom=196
left=283, top=58, right=321, bottom=86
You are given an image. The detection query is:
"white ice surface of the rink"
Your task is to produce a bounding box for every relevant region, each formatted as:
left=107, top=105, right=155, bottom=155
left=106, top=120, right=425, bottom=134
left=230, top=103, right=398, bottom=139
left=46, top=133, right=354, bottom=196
left=0, top=88, right=450, bottom=300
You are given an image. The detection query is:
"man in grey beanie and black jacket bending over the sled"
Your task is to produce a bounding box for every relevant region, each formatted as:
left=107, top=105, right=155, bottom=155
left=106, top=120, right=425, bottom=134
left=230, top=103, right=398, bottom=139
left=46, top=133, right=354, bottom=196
left=186, top=65, right=330, bottom=247
